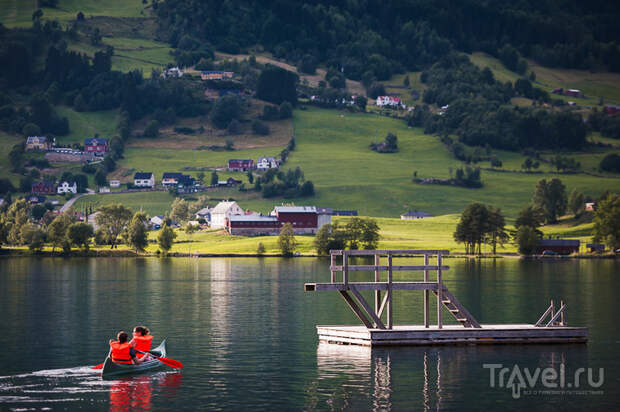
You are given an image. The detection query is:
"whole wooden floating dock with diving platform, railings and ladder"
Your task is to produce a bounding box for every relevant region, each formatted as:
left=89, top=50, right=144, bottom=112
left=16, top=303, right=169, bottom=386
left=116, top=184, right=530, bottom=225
left=305, top=250, right=588, bottom=347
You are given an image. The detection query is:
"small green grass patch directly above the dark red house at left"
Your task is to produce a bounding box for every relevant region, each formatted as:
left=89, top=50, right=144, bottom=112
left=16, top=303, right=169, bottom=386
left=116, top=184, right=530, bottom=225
left=56, top=106, right=118, bottom=145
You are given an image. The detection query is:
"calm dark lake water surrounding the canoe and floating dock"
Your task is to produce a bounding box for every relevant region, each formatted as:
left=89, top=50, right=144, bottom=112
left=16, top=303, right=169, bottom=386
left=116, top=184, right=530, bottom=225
left=0, top=258, right=620, bottom=411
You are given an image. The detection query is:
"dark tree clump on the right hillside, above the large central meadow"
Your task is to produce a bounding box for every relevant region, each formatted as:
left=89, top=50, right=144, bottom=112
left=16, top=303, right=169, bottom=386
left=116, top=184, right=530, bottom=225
left=407, top=54, right=587, bottom=150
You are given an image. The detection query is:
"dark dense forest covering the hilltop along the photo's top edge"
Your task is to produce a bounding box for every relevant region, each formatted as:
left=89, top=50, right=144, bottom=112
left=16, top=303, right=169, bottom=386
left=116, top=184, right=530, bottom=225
left=156, top=0, right=620, bottom=80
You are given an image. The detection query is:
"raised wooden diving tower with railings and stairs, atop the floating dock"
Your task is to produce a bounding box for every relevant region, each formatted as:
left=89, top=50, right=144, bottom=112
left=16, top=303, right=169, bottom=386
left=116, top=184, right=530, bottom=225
left=305, top=249, right=480, bottom=329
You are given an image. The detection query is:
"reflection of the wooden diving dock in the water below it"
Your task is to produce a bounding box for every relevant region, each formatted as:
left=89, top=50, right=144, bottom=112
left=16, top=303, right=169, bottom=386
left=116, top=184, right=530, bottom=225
left=314, top=343, right=587, bottom=411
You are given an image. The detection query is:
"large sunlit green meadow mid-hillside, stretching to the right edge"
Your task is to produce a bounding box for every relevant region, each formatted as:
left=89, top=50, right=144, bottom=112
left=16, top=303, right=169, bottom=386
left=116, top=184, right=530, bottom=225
left=287, top=109, right=620, bottom=217
